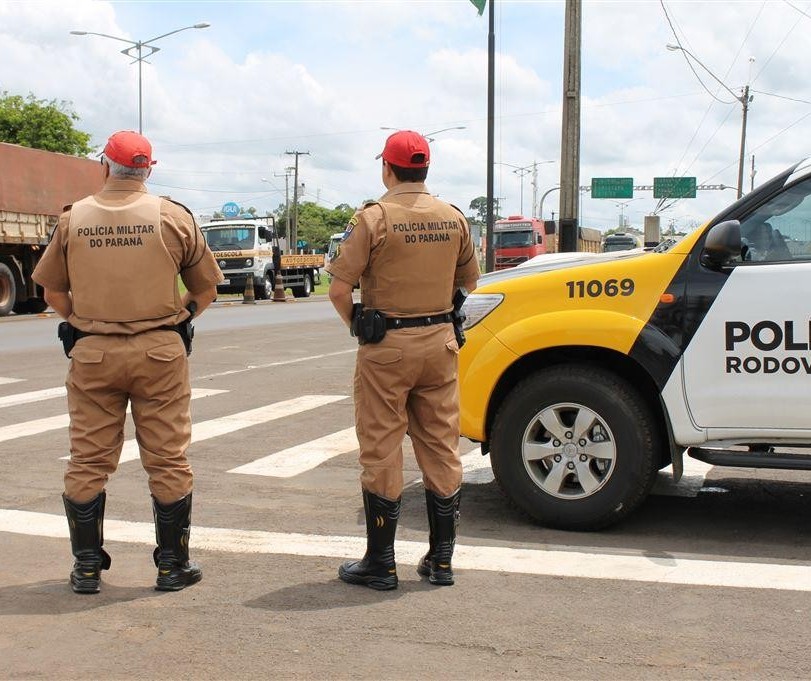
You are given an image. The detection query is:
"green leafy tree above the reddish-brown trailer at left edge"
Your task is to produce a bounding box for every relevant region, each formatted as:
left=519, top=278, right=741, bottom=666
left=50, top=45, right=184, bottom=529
left=0, top=90, right=95, bottom=156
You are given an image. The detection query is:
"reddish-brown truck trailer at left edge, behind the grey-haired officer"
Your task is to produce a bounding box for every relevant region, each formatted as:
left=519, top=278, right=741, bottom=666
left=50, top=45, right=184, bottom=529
left=0, top=142, right=104, bottom=317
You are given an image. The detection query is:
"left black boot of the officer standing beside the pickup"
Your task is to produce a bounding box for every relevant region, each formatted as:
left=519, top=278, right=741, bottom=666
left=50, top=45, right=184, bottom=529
left=338, top=490, right=400, bottom=591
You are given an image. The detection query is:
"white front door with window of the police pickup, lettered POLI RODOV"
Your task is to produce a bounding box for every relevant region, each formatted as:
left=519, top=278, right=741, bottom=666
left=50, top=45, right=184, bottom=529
left=682, top=179, right=811, bottom=431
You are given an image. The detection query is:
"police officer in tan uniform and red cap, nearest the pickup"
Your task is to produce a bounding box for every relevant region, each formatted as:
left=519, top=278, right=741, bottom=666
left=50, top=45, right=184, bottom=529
left=327, top=130, right=479, bottom=590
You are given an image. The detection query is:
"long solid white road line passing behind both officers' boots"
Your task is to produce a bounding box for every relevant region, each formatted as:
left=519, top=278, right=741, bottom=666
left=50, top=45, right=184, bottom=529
left=0, top=509, right=811, bottom=592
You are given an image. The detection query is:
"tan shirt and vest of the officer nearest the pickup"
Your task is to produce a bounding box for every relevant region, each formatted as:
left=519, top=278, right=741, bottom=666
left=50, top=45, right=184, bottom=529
left=327, top=182, right=479, bottom=317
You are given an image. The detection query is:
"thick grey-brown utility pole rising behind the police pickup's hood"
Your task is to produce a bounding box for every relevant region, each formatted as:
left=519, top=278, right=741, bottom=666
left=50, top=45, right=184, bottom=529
left=558, top=0, right=581, bottom=251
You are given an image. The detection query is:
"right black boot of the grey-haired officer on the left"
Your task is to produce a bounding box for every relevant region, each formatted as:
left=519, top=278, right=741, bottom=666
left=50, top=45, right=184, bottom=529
left=152, top=494, right=203, bottom=591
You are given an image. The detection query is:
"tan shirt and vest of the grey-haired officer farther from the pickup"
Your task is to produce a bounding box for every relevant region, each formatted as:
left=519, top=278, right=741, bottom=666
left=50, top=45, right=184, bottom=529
left=33, top=178, right=222, bottom=334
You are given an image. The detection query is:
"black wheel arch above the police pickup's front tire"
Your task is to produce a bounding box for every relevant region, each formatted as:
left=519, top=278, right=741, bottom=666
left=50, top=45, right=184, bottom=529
left=485, top=345, right=676, bottom=468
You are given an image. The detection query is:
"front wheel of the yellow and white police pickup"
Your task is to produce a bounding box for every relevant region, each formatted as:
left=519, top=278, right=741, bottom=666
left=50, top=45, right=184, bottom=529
left=490, top=365, right=660, bottom=530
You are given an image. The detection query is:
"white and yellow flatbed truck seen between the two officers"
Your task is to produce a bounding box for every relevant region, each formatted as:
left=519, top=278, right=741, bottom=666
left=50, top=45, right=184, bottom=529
left=200, top=218, right=324, bottom=300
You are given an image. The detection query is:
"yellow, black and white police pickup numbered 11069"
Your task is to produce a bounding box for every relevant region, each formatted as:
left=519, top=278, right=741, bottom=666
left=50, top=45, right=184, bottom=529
left=459, top=160, right=811, bottom=530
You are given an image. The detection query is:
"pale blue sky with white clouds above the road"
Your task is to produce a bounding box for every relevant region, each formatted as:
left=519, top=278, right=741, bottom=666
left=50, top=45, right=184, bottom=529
left=0, top=0, right=811, bottom=230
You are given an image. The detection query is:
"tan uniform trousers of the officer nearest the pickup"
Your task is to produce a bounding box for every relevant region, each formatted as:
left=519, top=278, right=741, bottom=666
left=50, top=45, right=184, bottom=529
left=354, top=324, right=462, bottom=500
